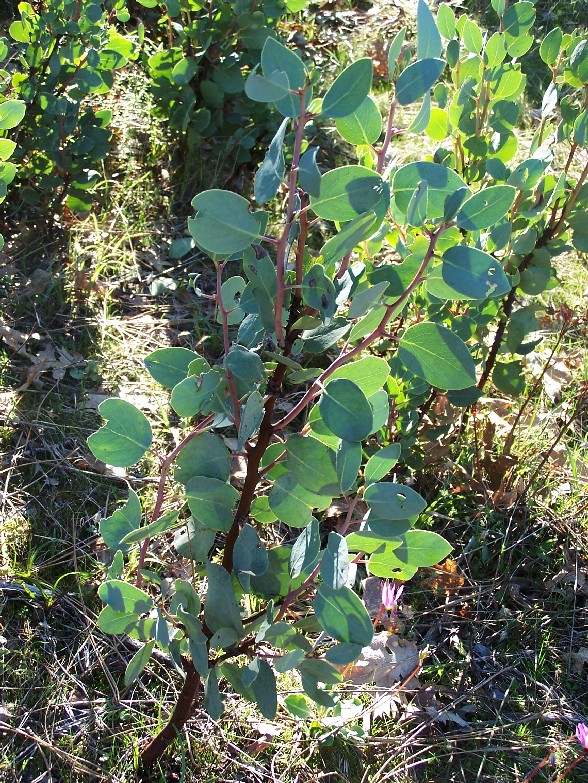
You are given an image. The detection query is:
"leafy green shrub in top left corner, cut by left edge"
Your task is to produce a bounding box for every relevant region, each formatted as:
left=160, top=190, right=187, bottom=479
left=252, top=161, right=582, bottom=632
left=0, top=0, right=136, bottom=211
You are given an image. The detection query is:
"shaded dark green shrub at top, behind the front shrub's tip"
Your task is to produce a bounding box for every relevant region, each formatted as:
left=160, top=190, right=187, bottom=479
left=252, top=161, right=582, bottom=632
left=138, top=0, right=308, bottom=158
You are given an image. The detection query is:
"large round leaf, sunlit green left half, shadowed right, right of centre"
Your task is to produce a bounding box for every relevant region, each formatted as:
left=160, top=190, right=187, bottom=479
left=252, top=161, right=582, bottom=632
left=398, top=321, right=476, bottom=389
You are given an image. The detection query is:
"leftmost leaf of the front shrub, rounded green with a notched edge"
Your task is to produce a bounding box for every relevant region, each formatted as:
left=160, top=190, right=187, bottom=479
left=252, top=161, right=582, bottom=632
left=88, top=397, right=153, bottom=468
